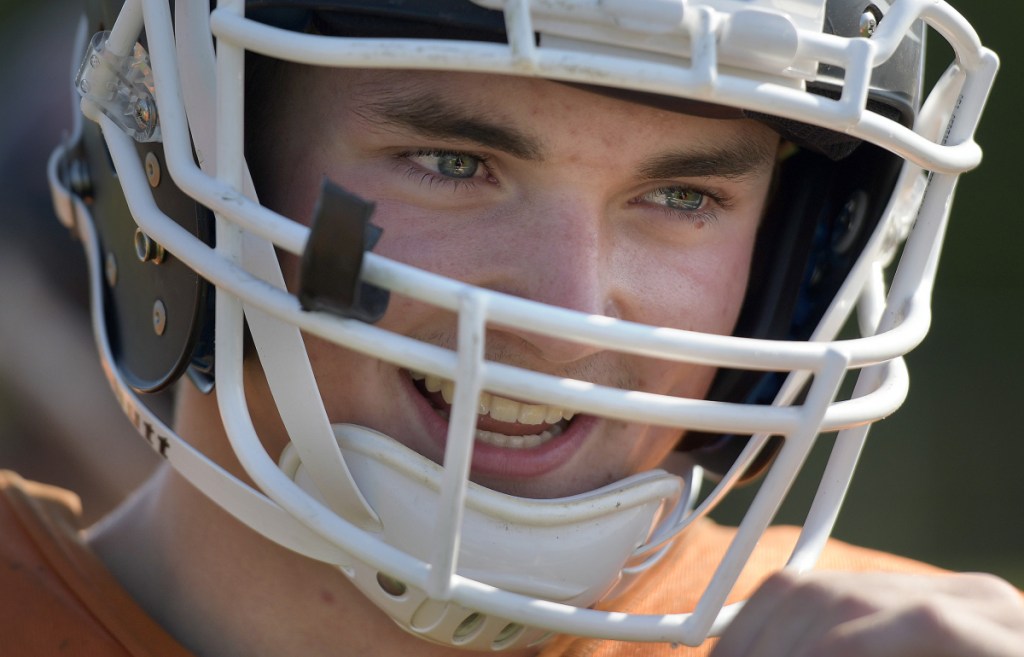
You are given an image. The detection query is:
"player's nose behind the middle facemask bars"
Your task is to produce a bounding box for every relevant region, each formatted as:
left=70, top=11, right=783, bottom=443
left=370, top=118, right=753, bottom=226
left=475, top=191, right=625, bottom=363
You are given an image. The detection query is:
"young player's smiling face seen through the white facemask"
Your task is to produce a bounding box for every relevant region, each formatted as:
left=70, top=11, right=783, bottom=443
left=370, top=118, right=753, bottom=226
left=257, top=69, right=778, bottom=497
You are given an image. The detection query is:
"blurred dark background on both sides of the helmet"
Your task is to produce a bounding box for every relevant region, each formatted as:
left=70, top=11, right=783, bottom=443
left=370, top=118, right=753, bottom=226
left=0, top=0, right=1024, bottom=587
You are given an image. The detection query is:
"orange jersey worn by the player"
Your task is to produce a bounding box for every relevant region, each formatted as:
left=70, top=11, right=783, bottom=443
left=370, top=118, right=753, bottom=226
left=0, top=471, right=940, bottom=657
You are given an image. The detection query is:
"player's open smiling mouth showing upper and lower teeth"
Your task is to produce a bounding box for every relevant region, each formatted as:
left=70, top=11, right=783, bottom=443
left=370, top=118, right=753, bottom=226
left=409, top=371, right=575, bottom=449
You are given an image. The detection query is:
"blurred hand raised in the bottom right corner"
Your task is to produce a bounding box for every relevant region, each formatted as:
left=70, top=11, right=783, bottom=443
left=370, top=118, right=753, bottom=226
left=712, top=571, right=1024, bottom=657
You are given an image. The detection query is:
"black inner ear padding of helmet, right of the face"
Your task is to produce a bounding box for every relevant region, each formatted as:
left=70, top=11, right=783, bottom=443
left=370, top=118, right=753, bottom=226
left=678, top=143, right=902, bottom=480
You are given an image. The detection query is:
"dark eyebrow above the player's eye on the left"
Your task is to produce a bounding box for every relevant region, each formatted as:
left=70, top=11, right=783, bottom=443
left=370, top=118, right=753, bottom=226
left=355, top=92, right=544, bottom=161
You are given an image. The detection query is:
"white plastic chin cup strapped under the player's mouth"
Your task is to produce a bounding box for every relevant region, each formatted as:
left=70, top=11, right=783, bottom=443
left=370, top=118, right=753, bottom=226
left=281, top=425, right=683, bottom=650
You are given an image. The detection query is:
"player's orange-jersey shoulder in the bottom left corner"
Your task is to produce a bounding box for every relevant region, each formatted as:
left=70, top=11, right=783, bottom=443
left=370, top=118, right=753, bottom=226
left=0, top=471, right=190, bottom=657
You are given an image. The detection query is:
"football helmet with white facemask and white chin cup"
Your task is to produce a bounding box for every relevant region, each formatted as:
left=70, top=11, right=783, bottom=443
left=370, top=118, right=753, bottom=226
left=49, top=0, right=997, bottom=650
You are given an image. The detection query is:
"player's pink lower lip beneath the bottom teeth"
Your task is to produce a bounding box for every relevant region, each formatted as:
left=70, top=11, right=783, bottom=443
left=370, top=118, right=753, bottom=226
left=404, top=375, right=597, bottom=479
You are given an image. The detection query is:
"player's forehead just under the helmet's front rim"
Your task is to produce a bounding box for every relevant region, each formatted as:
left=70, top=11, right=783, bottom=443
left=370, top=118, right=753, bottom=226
left=300, top=69, right=778, bottom=157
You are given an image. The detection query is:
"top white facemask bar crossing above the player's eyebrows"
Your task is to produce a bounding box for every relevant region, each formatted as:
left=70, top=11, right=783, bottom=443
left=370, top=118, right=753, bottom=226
left=210, top=0, right=997, bottom=173
